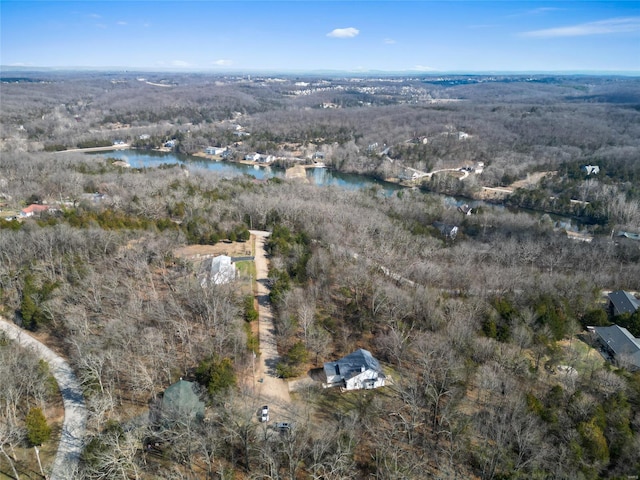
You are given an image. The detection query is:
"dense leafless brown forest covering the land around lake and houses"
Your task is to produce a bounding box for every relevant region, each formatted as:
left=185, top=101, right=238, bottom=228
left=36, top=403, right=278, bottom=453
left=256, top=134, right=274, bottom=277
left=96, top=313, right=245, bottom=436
left=0, top=72, right=640, bottom=480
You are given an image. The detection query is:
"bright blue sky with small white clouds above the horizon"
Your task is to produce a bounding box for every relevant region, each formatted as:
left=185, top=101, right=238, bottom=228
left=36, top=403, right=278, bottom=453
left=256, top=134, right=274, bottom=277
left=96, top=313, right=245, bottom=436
left=0, top=0, right=640, bottom=73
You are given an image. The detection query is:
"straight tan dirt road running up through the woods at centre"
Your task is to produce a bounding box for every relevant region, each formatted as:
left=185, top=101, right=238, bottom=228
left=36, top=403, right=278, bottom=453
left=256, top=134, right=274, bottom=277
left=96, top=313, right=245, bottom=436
left=251, top=230, right=291, bottom=403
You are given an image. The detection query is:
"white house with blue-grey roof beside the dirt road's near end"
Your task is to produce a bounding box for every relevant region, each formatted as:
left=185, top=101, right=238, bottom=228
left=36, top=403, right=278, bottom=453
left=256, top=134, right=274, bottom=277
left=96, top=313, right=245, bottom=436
left=324, top=348, right=386, bottom=390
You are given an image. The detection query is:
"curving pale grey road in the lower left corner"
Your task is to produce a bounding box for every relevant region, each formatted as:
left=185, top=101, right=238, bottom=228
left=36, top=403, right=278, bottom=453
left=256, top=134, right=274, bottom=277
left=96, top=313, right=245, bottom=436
left=0, top=318, right=87, bottom=480
